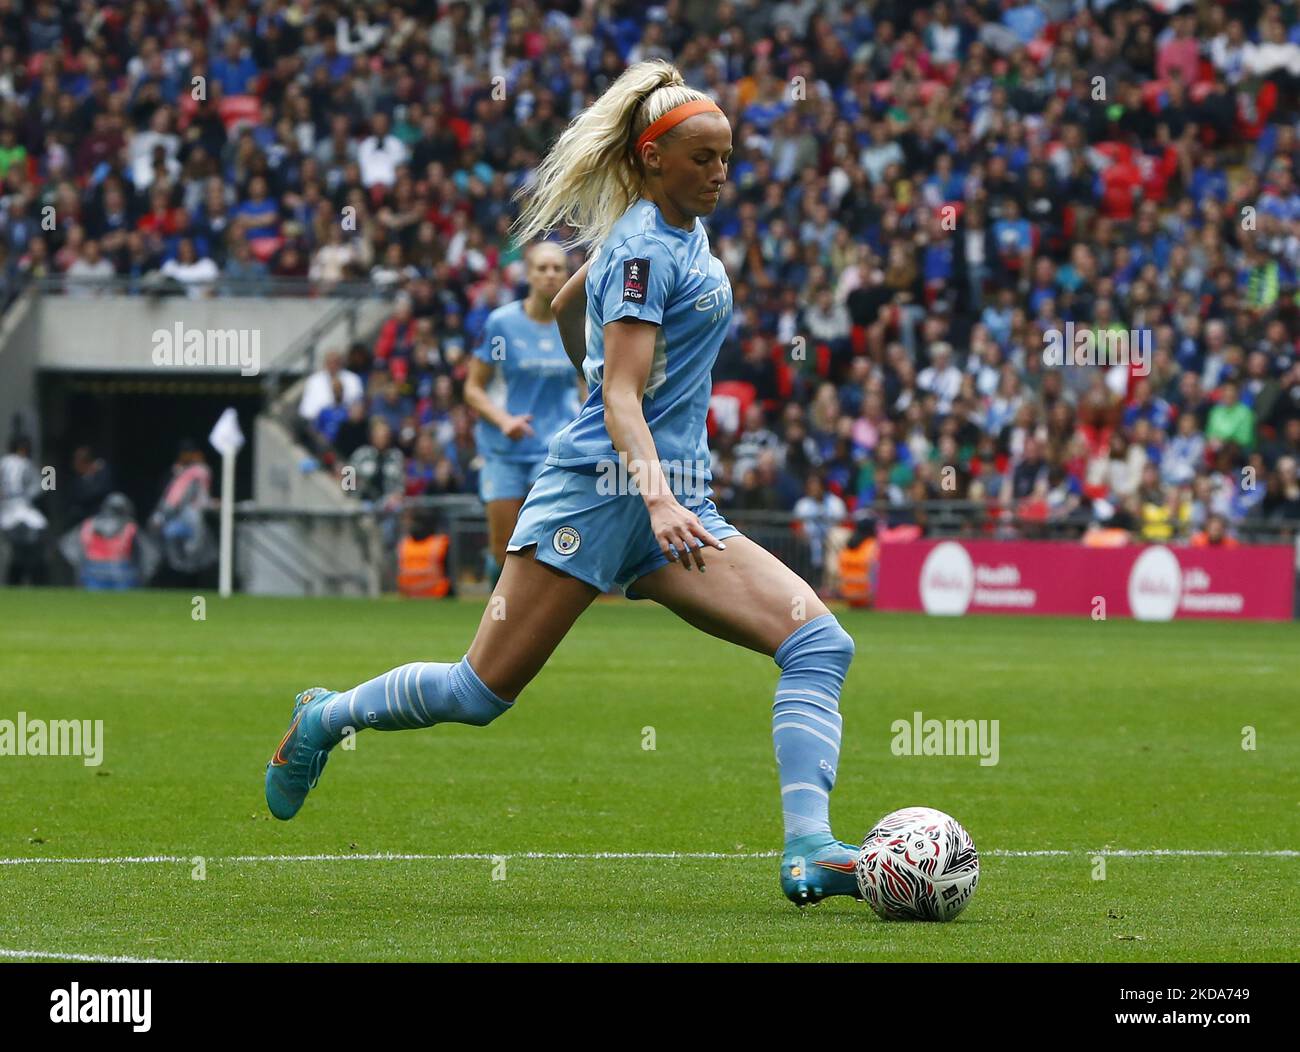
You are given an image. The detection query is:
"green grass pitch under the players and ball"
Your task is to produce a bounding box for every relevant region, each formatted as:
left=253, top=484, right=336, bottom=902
left=0, top=592, right=1300, bottom=961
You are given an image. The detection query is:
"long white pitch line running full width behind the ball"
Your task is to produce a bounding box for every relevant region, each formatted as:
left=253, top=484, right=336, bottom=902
left=0, top=848, right=1300, bottom=866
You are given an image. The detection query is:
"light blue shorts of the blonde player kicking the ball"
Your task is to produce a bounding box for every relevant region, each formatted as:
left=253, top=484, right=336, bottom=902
left=506, top=467, right=740, bottom=599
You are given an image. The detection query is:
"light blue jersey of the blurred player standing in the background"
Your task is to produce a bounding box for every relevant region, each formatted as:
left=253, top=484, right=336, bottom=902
left=475, top=300, right=577, bottom=462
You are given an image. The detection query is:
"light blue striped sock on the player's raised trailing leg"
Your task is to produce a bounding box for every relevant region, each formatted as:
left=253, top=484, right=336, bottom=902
left=321, top=657, right=514, bottom=741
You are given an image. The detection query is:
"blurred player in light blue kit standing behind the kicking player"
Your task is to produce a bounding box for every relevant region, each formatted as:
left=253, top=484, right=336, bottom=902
left=465, top=242, right=580, bottom=584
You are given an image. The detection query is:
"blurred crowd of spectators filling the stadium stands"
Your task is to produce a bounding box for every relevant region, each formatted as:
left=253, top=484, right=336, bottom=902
left=0, top=0, right=1300, bottom=582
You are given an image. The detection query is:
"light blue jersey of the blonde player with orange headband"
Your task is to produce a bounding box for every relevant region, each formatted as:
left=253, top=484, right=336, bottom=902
left=546, top=200, right=732, bottom=482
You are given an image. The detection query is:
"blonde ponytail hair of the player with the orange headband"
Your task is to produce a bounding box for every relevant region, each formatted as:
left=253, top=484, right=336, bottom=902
left=514, top=59, right=709, bottom=250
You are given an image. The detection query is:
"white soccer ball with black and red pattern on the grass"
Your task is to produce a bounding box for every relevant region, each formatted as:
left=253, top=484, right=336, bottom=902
left=855, top=808, right=979, bottom=921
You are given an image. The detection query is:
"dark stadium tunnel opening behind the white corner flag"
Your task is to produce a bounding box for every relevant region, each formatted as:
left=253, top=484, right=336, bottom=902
left=38, top=372, right=263, bottom=531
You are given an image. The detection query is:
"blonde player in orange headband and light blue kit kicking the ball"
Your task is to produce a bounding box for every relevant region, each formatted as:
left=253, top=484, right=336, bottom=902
left=267, top=61, right=858, bottom=905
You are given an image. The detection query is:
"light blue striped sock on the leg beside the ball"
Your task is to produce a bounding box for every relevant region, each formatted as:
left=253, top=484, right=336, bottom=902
left=772, top=614, right=853, bottom=843
